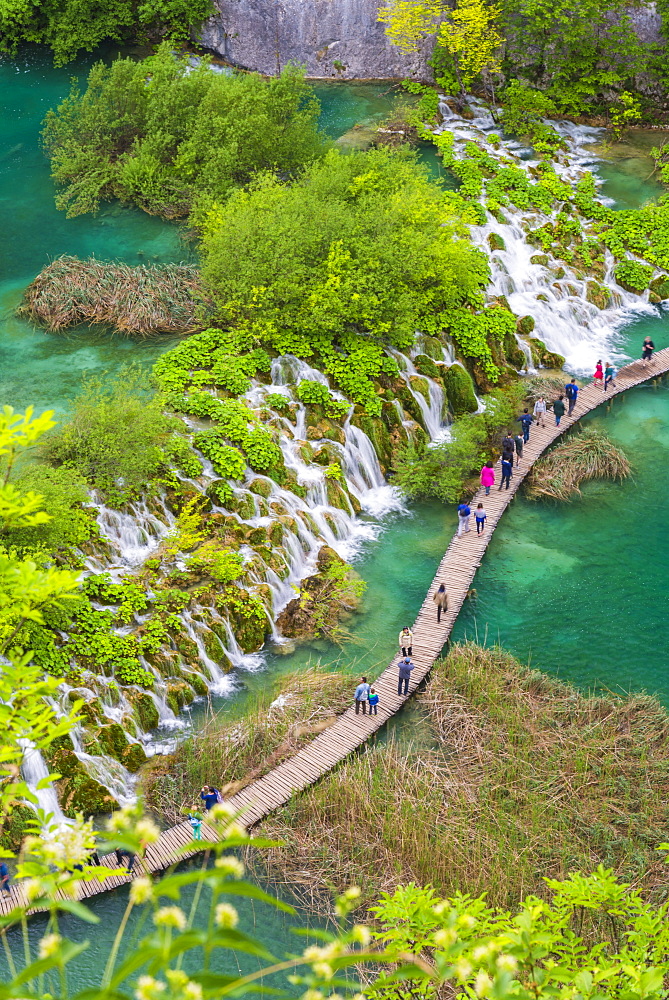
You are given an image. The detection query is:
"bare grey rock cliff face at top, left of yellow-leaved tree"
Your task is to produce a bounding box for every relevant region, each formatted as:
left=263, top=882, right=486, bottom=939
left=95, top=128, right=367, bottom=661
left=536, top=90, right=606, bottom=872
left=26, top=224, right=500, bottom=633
left=200, top=0, right=433, bottom=80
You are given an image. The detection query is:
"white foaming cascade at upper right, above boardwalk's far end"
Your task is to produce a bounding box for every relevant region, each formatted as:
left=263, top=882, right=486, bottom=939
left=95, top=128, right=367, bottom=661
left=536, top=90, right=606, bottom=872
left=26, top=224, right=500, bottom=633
left=436, top=102, right=656, bottom=375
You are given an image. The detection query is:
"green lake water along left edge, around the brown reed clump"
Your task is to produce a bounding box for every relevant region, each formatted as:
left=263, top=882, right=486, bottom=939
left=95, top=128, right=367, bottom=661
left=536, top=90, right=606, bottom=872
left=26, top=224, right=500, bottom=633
left=0, top=50, right=189, bottom=411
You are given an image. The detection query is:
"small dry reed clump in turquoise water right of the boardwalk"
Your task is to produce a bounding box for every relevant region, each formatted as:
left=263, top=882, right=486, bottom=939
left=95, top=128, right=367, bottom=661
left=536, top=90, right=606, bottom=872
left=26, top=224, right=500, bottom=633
left=527, top=427, right=631, bottom=500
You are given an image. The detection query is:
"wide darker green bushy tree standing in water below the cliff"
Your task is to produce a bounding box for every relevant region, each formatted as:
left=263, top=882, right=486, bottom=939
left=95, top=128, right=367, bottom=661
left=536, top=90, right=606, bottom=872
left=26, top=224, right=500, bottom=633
left=43, top=43, right=325, bottom=218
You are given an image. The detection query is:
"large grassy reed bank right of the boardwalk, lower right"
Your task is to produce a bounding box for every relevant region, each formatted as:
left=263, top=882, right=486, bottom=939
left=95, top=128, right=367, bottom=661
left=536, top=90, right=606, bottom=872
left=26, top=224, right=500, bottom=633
left=249, top=645, right=669, bottom=906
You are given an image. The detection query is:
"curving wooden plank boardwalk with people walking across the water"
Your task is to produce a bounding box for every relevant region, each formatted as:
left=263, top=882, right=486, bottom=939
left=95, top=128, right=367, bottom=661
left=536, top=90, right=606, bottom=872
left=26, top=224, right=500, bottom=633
left=0, top=348, right=669, bottom=913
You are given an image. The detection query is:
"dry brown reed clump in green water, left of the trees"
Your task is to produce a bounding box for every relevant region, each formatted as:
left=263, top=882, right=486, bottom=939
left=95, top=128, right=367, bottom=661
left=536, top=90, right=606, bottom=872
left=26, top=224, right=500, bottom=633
left=19, top=255, right=204, bottom=337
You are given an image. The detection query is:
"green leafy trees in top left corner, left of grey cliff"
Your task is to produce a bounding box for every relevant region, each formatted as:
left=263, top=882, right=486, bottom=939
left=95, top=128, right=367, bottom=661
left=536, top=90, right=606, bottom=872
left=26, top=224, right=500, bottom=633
left=0, top=0, right=214, bottom=66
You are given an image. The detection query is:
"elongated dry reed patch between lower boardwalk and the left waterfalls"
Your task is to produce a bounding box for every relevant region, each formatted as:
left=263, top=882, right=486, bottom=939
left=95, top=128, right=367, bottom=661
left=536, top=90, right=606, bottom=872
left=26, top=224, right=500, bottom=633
left=143, top=666, right=353, bottom=823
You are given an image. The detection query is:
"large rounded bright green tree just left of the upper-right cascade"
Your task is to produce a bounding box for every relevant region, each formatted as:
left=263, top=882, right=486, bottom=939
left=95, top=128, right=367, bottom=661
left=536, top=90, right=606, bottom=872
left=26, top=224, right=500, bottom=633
left=203, top=149, right=488, bottom=412
